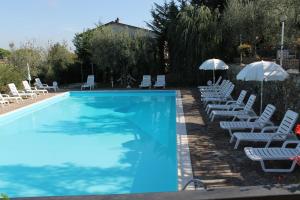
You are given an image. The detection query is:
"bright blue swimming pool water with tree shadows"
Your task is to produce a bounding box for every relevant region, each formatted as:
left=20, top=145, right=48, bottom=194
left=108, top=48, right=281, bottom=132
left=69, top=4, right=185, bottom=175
left=0, top=91, right=177, bottom=197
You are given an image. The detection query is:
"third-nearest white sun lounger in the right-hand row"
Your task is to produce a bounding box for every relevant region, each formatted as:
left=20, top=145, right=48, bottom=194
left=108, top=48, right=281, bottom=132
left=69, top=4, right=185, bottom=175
left=220, top=104, right=276, bottom=136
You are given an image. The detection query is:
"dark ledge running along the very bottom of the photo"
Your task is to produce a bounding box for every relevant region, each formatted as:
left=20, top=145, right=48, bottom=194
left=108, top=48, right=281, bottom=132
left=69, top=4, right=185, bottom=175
left=14, top=185, right=300, bottom=200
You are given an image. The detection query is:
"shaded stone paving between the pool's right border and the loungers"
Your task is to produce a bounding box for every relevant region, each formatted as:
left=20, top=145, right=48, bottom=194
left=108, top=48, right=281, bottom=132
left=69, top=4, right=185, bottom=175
left=181, top=89, right=300, bottom=187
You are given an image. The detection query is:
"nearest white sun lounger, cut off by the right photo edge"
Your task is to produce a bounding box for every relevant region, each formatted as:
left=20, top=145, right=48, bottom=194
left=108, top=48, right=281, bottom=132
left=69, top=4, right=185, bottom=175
left=244, top=141, right=300, bottom=173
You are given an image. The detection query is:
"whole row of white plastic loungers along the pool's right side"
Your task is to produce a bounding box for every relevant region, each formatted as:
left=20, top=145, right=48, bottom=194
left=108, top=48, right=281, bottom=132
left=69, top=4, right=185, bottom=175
left=198, top=80, right=300, bottom=172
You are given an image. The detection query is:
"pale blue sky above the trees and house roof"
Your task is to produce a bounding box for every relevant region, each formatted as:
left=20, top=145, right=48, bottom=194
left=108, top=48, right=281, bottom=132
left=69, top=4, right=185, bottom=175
left=0, top=0, right=164, bottom=49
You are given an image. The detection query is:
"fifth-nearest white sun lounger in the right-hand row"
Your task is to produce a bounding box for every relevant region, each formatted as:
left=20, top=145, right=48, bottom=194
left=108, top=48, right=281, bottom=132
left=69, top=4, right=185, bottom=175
left=205, top=90, right=247, bottom=114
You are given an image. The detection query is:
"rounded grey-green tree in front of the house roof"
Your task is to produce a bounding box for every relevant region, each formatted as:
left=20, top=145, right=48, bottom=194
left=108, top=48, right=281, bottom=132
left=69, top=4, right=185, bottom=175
left=91, top=27, right=156, bottom=82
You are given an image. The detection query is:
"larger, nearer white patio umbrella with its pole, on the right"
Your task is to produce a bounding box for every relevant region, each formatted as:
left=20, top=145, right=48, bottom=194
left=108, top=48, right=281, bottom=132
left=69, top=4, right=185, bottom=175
left=236, top=61, right=289, bottom=113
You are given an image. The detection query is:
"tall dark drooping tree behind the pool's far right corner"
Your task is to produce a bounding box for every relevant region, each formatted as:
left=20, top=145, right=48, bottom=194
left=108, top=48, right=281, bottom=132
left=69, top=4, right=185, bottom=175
left=149, top=1, right=221, bottom=85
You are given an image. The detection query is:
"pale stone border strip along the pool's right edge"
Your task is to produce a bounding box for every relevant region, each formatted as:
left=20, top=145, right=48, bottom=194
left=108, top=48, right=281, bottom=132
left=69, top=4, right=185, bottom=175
left=176, top=90, right=194, bottom=191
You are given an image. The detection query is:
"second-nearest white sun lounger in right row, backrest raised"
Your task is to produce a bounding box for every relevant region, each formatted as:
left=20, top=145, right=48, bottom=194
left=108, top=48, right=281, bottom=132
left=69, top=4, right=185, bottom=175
left=230, top=110, right=298, bottom=149
